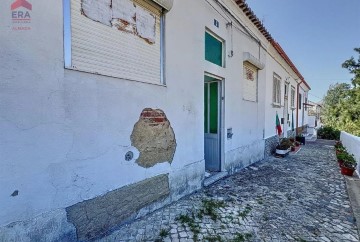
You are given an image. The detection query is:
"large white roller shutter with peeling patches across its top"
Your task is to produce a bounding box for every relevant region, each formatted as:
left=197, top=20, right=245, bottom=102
left=71, top=0, right=162, bottom=84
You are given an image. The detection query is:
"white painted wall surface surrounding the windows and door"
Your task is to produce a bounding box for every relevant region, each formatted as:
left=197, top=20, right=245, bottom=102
left=0, top=0, right=310, bottom=233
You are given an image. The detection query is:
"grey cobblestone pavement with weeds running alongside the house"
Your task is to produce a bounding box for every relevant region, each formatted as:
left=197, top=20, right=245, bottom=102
left=97, top=141, right=359, bottom=242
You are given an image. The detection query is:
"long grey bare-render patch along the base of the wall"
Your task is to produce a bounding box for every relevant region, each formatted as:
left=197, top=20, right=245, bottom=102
left=66, top=175, right=170, bottom=240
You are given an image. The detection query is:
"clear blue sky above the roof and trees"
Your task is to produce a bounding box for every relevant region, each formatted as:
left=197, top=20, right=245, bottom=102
left=246, top=0, right=360, bottom=102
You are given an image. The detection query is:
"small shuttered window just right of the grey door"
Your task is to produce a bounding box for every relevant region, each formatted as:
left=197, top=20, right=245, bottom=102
left=243, top=62, right=258, bottom=102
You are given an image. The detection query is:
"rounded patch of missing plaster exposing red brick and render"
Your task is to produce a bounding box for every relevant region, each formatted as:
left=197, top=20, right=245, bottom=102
left=131, top=108, right=176, bottom=168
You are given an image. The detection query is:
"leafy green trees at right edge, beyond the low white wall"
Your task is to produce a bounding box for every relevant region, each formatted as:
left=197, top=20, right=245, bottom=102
left=323, top=48, right=360, bottom=136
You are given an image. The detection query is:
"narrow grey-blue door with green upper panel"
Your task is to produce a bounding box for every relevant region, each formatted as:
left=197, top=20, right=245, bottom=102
left=204, top=76, right=221, bottom=171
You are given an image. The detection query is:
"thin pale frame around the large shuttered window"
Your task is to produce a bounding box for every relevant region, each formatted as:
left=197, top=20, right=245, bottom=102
left=63, top=0, right=166, bottom=86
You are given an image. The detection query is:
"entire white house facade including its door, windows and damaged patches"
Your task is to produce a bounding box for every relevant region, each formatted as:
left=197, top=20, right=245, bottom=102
left=0, top=0, right=310, bottom=241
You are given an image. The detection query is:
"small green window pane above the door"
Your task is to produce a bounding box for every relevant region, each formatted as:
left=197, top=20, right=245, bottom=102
left=205, top=32, right=224, bottom=66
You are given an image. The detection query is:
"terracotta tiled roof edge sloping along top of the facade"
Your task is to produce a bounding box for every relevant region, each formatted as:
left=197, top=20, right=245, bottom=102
left=234, top=0, right=311, bottom=89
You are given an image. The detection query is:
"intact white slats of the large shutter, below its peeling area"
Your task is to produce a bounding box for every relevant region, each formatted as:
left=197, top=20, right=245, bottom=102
left=71, top=0, right=161, bottom=84
